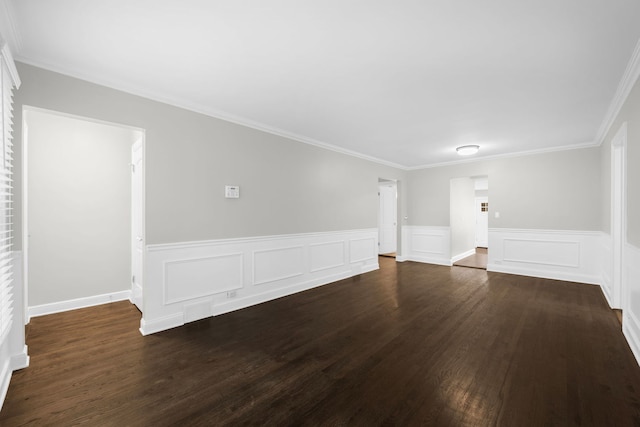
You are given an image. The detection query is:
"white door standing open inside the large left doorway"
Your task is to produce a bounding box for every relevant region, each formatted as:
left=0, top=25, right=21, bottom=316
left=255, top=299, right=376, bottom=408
left=131, top=139, right=144, bottom=312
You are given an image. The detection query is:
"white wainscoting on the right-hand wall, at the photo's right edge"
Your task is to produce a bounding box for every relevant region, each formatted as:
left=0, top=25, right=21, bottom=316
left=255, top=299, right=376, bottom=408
left=622, top=244, right=640, bottom=365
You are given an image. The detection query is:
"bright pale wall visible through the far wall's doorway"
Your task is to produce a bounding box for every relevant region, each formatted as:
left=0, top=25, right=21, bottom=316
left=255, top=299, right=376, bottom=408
left=450, top=177, right=476, bottom=257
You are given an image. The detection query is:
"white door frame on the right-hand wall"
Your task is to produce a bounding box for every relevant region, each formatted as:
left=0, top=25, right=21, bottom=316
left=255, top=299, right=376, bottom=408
left=611, top=122, right=628, bottom=310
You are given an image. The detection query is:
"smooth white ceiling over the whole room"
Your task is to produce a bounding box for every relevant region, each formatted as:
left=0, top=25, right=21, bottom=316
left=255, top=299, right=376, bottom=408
left=0, top=0, right=640, bottom=168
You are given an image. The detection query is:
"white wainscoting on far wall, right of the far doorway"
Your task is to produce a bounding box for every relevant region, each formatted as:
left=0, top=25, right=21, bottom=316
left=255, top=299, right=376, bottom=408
left=487, top=228, right=602, bottom=284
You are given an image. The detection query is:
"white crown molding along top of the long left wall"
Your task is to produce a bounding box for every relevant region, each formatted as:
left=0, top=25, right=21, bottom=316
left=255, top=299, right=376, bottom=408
left=15, top=56, right=407, bottom=170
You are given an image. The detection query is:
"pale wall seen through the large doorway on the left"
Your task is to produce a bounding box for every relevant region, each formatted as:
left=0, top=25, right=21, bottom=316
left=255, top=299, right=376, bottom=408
left=27, top=111, right=136, bottom=306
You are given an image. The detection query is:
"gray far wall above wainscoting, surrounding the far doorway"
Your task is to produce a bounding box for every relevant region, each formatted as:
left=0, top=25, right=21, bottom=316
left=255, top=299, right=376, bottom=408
left=407, top=147, right=601, bottom=231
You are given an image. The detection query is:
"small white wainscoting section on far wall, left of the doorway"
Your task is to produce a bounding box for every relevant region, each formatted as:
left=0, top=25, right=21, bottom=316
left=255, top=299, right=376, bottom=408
left=398, top=225, right=451, bottom=265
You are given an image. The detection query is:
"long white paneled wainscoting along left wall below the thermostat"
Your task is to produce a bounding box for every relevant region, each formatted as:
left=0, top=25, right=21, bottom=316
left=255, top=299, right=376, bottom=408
left=140, top=228, right=378, bottom=335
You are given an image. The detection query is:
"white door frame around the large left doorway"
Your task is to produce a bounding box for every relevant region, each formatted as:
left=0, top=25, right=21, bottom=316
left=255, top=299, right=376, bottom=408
left=21, top=105, right=146, bottom=325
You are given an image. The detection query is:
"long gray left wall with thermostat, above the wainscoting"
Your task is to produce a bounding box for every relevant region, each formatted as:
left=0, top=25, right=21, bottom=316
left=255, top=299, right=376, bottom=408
left=15, top=63, right=406, bottom=249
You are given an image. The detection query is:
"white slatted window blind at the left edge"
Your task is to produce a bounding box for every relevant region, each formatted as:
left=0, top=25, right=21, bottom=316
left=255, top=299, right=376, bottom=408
left=0, top=48, right=14, bottom=344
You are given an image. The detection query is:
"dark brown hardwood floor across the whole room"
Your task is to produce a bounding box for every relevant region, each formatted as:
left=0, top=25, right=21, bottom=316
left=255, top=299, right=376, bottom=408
left=0, top=258, right=640, bottom=427
